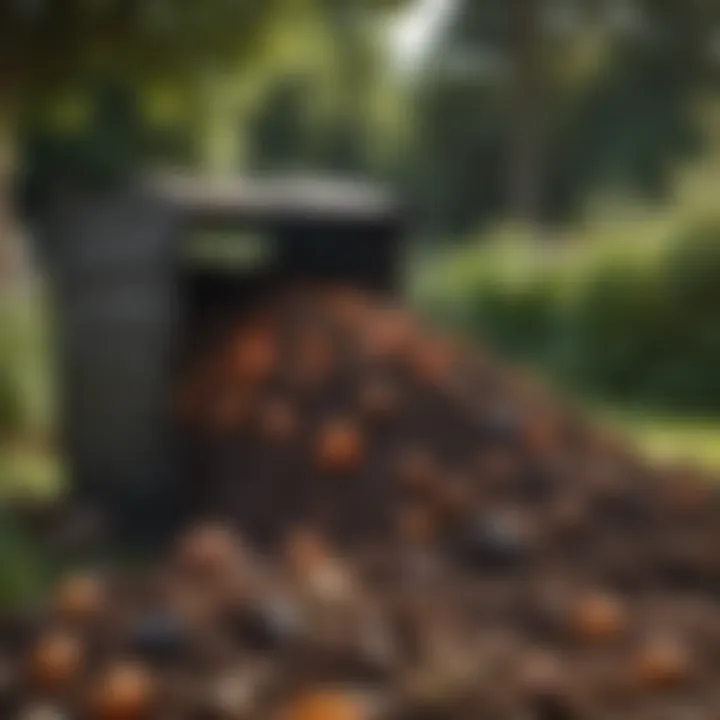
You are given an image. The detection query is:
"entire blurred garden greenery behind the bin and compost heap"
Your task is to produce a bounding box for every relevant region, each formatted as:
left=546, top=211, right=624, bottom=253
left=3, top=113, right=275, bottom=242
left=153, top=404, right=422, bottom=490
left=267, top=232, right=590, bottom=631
left=0, top=0, right=720, bottom=506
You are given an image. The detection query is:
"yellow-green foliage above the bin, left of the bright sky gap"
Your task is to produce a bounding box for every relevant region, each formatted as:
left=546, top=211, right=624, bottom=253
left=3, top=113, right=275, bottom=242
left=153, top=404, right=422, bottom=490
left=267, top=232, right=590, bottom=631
left=12, top=0, right=406, bottom=187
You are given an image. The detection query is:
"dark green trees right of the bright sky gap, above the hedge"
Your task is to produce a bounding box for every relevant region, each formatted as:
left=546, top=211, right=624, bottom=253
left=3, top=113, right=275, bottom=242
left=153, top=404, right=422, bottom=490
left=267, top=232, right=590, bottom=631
left=406, top=0, right=720, bottom=234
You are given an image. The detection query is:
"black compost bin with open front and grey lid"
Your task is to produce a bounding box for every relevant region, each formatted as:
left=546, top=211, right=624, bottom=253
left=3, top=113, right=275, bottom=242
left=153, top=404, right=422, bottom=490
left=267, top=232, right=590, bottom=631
left=33, top=175, right=402, bottom=536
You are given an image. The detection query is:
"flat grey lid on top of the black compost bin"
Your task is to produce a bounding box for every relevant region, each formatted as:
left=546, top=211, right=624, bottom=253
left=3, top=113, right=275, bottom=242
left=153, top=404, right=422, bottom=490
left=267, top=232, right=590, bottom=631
left=151, top=173, right=400, bottom=222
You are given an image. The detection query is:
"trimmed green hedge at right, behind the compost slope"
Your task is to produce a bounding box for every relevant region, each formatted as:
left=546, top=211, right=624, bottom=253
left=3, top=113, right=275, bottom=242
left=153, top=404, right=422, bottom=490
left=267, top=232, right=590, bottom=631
left=420, top=217, right=720, bottom=411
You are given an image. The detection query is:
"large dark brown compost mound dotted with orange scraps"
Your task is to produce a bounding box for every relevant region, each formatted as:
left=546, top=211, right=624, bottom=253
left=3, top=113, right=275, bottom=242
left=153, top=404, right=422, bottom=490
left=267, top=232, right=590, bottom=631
left=0, top=287, right=720, bottom=720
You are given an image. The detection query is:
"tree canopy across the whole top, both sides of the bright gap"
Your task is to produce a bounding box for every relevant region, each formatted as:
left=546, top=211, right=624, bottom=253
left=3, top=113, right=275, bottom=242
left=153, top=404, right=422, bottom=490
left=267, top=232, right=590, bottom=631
left=5, top=0, right=720, bottom=234
